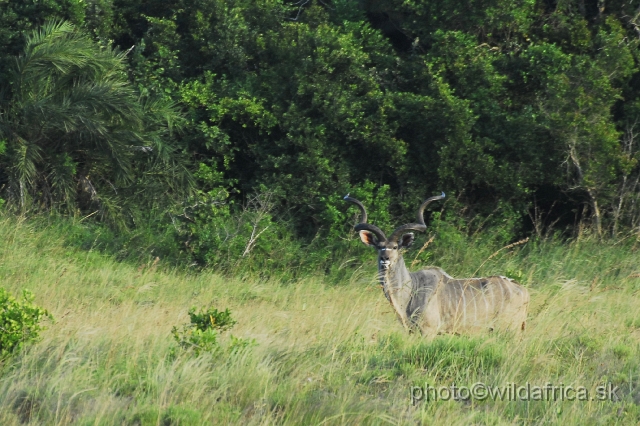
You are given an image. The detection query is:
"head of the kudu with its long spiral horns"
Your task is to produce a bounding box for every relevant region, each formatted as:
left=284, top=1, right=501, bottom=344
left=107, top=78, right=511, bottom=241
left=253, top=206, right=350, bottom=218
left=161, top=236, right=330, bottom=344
left=344, top=192, right=445, bottom=271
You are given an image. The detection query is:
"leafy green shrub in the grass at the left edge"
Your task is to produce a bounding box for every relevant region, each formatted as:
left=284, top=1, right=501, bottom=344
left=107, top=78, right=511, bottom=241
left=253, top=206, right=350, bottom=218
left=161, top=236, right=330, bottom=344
left=0, top=287, right=52, bottom=360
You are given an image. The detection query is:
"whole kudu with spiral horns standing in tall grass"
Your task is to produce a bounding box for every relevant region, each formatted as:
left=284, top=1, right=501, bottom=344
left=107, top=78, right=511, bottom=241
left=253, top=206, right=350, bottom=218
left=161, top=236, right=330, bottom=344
left=344, top=193, right=529, bottom=335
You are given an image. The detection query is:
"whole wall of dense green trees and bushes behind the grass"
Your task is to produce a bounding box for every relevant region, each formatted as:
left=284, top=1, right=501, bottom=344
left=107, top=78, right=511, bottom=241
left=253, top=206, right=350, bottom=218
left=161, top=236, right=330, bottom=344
left=0, top=0, right=640, bottom=270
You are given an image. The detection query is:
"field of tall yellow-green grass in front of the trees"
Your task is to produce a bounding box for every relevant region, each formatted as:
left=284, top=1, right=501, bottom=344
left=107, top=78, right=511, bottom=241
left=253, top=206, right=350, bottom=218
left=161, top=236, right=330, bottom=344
left=0, top=215, right=640, bottom=425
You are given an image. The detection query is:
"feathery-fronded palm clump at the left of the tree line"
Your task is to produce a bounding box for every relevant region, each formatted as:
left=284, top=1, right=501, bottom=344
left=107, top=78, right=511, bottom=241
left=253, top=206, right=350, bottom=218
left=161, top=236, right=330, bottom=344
left=0, top=21, right=193, bottom=220
